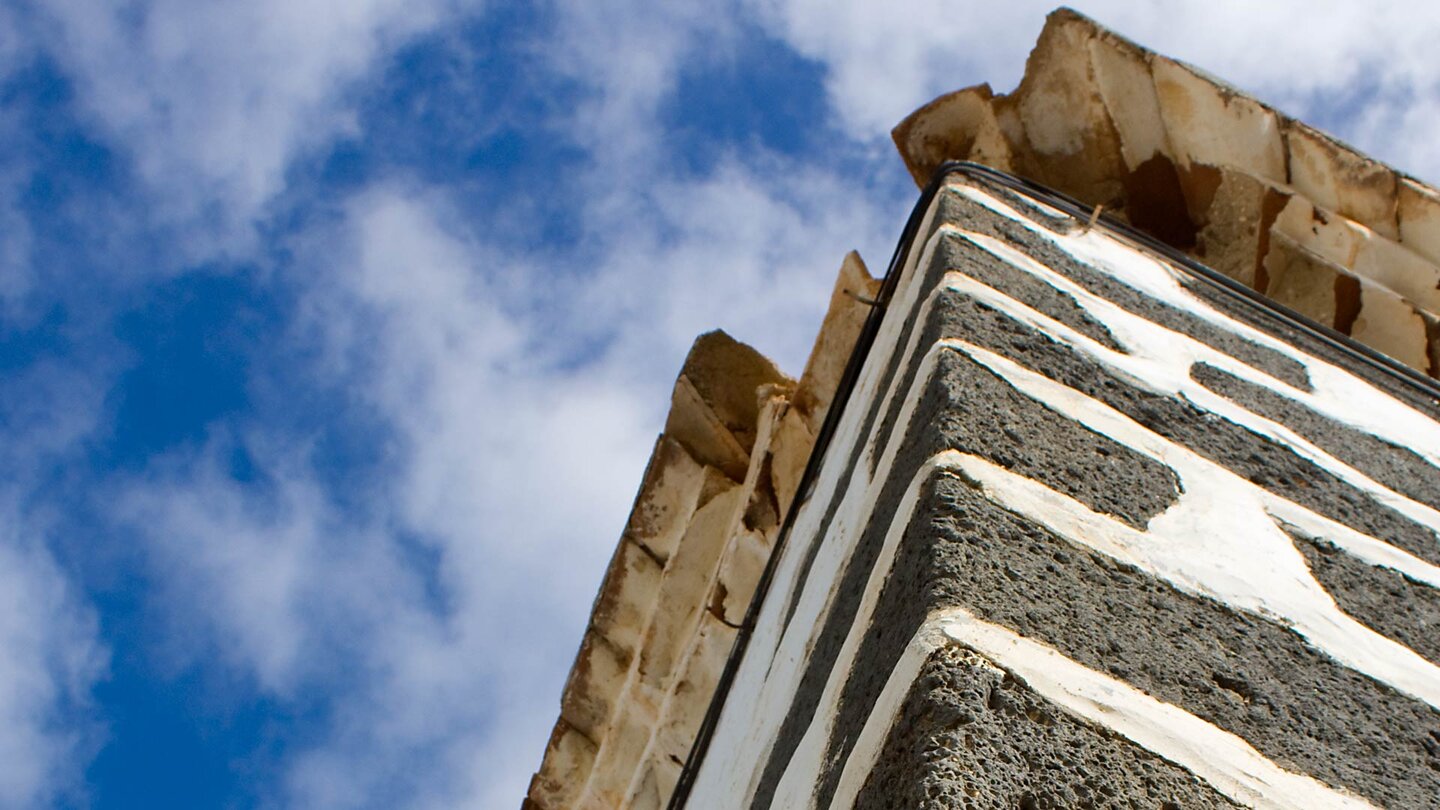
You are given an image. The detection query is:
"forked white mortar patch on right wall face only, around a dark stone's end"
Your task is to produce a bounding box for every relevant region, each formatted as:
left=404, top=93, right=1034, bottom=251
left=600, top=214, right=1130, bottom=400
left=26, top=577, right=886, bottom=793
left=943, top=340, right=1440, bottom=709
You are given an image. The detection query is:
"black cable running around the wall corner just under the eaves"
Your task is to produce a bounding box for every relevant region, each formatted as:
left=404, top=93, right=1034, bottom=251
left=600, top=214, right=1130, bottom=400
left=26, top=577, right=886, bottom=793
left=668, top=160, right=1440, bottom=810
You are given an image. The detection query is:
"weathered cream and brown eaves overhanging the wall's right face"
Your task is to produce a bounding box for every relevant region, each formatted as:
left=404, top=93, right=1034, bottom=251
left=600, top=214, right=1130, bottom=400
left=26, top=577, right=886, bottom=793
left=893, top=9, right=1440, bottom=373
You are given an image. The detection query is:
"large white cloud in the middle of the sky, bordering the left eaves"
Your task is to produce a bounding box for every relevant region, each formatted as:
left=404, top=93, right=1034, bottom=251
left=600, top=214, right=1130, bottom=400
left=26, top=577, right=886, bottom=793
left=115, top=134, right=898, bottom=807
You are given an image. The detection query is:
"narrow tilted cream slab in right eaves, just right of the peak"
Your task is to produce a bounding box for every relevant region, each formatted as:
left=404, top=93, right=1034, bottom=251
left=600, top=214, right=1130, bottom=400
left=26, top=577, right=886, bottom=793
left=1089, top=36, right=1171, bottom=172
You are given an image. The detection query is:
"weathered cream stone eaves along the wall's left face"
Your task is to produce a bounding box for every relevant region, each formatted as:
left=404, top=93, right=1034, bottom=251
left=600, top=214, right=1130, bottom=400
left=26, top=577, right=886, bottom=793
left=526, top=254, right=878, bottom=810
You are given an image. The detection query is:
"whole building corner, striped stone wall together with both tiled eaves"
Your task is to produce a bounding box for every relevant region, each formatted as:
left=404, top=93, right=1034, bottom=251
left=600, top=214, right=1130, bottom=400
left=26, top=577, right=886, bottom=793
left=527, top=10, right=1440, bottom=810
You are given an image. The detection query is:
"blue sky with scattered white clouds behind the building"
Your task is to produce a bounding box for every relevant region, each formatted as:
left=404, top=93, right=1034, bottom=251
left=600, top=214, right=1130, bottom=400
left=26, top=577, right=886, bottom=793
left=0, top=0, right=1440, bottom=809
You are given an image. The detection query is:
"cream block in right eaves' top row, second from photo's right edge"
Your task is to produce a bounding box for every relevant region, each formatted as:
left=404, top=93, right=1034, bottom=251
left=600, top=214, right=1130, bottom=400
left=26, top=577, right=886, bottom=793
left=1284, top=121, right=1400, bottom=239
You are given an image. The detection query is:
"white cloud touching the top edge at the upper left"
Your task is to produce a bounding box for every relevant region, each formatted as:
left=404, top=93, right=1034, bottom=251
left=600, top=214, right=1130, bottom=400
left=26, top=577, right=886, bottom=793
left=26, top=0, right=472, bottom=249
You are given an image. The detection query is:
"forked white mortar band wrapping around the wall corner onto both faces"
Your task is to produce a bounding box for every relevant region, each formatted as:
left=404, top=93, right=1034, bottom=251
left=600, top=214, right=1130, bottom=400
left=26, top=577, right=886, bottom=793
left=772, top=314, right=1440, bottom=807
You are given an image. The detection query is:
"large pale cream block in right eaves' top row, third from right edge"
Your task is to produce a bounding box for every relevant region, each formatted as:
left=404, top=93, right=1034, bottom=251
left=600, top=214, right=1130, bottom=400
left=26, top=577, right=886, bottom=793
left=1151, top=56, right=1286, bottom=183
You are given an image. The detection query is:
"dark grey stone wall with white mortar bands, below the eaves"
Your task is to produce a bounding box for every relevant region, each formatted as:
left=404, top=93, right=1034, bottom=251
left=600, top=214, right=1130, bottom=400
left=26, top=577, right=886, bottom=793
left=687, top=171, right=1440, bottom=810
